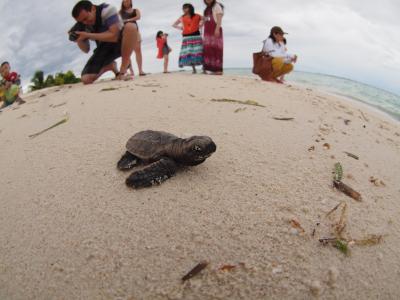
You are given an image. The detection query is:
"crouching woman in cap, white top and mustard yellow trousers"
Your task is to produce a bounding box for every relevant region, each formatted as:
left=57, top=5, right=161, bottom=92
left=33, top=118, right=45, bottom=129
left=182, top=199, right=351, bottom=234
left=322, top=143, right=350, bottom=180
left=263, top=26, right=297, bottom=83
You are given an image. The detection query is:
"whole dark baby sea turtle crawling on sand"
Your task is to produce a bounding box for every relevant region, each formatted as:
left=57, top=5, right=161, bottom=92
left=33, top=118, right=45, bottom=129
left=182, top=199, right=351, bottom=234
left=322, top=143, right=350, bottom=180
left=118, top=130, right=217, bottom=188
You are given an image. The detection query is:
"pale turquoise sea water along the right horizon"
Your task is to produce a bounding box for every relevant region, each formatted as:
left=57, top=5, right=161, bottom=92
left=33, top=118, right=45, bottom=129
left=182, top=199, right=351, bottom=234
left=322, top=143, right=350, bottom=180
left=225, top=69, right=400, bottom=121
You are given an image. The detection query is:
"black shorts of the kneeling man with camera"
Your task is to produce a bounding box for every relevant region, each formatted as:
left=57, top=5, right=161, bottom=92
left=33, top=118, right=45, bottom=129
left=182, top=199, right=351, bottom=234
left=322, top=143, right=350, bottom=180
left=82, top=30, right=123, bottom=76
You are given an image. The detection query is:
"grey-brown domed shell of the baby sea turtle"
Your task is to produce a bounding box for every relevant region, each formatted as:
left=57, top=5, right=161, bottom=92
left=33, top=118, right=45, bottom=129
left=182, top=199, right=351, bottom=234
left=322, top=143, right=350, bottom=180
left=126, top=130, right=179, bottom=161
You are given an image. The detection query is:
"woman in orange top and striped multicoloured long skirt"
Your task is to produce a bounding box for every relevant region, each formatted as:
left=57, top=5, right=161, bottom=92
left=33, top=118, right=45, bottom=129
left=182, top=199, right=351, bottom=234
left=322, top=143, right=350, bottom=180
left=172, top=3, right=203, bottom=74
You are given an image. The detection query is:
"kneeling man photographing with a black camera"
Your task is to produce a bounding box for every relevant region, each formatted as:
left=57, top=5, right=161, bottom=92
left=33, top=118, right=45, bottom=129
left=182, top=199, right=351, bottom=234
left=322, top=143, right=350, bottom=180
left=69, top=0, right=138, bottom=84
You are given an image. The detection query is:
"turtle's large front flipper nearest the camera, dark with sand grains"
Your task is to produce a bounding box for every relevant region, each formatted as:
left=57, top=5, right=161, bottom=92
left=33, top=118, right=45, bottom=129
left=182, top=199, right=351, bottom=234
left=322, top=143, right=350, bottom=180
left=126, top=158, right=177, bottom=189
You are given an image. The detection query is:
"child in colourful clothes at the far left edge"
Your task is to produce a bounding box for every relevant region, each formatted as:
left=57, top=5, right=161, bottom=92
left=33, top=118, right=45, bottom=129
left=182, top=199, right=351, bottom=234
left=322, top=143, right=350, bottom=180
left=0, top=62, right=25, bottom=108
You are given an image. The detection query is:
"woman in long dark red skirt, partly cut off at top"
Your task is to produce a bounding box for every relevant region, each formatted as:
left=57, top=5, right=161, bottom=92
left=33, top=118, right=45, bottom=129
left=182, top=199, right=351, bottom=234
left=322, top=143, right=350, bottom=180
left=203, top=0, right=224, bottom=75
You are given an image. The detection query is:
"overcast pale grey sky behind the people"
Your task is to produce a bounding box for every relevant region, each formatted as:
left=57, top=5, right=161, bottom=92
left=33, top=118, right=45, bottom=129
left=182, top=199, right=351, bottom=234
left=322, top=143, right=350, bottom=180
left=0, top=0, right=400, bottom=94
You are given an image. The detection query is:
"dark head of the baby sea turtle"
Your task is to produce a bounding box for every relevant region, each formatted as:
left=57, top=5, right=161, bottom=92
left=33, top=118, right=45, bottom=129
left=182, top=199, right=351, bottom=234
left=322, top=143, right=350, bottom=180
left=179, top=136, right=217, bottom=166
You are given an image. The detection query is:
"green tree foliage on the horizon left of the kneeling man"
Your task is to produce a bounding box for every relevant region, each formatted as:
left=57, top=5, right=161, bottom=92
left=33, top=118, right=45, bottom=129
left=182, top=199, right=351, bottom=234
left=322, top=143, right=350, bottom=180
left=30, top=71, right=81, bottom=91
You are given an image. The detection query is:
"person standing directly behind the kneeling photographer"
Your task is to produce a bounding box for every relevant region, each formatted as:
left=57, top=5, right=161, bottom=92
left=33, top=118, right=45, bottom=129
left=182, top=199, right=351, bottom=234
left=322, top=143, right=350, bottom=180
left=119, top=0, right=146, bottom=76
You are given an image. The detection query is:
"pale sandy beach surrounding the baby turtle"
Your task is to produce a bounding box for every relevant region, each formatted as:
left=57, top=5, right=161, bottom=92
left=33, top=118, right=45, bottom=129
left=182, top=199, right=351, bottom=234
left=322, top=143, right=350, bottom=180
left=0, top=73, right=400, bottom=300
